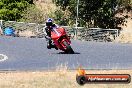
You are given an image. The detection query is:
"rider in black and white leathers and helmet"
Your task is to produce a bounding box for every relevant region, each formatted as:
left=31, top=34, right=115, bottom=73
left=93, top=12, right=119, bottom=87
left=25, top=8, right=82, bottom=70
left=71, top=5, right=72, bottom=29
left=44, top=18, right=59, bottom=50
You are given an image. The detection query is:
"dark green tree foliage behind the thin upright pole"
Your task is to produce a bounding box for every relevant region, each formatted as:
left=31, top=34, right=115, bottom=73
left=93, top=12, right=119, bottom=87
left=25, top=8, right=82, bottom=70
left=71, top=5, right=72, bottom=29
left=53, top=0, right=129, bottom=28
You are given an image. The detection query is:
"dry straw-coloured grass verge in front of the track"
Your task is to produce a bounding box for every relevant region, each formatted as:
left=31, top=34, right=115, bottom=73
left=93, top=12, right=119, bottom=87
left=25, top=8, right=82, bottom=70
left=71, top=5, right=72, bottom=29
left=0, top=70, right=132, bottom=88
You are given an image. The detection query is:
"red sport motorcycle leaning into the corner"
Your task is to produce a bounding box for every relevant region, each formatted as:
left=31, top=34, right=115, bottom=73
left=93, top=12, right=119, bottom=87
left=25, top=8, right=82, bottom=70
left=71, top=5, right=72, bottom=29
left=51, top=27, right=74, bottom=54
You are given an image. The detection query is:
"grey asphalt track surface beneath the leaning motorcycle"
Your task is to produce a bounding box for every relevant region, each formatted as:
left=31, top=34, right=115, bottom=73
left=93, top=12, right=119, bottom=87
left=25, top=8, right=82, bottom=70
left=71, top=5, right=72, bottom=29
left=0, top=37, right=132, bottom=71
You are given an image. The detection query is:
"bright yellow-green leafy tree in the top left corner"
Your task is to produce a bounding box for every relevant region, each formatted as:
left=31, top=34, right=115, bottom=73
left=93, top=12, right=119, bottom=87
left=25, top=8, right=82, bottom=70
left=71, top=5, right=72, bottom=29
left=0, top=0, right=33, bottom=20
